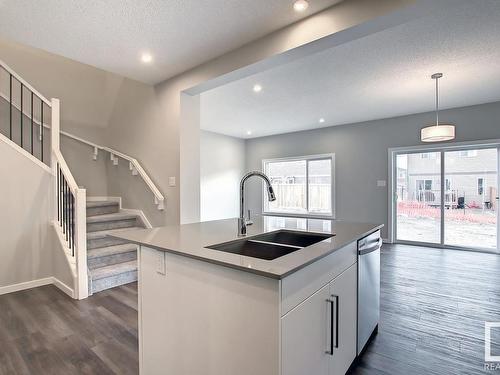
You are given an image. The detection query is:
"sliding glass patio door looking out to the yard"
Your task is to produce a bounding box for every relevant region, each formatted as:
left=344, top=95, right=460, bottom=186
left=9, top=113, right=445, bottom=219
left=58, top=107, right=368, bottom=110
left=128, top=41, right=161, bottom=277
left=393, top=146, right=500, bottom=250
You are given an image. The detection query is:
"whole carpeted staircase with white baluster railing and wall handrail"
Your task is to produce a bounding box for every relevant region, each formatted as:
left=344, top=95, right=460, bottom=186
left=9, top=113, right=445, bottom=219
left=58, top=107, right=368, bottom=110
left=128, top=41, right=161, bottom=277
left=0, top=58, right=165, bottom=299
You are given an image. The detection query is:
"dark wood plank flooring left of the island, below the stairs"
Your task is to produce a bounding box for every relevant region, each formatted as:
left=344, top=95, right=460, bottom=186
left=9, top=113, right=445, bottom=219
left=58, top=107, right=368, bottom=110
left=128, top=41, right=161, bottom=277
left=0, top=284, right=139, bottom=375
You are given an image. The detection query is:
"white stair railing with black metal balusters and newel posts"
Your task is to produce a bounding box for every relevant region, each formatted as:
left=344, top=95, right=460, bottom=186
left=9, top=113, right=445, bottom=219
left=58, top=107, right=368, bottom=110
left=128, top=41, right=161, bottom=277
left=0, top=60, right=88, bottom=299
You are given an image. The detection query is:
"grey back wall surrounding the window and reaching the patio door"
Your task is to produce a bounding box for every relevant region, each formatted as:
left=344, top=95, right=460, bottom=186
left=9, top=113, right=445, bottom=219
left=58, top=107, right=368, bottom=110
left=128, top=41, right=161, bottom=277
left=246, top=102, right=500, bottom=237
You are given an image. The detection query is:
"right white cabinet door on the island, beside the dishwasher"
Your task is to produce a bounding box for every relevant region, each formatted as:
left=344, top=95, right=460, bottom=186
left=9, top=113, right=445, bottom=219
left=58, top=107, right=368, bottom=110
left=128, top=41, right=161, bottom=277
left=328, top=264, right=358, bottom=375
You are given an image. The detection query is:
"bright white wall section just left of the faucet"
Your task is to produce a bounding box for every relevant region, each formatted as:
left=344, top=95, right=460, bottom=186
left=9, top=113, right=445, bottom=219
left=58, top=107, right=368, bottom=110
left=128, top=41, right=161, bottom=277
left=200, top=130, right=245, bottom=221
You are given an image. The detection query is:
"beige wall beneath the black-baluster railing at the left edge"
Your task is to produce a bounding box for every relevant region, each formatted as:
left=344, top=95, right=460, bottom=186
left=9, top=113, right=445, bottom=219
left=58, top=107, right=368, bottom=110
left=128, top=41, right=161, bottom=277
left=0, top=136, right=53, bottom=294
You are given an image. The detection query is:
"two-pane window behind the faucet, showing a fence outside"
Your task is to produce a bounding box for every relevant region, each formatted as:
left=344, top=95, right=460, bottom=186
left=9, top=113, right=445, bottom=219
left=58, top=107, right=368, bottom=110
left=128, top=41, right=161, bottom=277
left=263, top=155, right=335, bottom=216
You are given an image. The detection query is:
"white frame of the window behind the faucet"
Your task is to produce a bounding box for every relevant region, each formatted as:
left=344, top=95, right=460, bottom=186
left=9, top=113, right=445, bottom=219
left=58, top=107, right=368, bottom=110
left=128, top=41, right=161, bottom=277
left=262, top=154, right=337, bottom=220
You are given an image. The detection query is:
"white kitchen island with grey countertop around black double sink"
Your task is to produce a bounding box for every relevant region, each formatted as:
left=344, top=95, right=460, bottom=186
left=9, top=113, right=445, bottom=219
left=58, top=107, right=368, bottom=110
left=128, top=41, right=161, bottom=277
left=112, top=216, right=381, bottom=375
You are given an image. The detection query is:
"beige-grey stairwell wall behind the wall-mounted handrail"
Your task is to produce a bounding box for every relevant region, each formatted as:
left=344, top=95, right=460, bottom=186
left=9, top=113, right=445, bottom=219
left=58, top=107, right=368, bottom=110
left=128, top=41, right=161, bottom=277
left=0, top=39, right=170, bottom=225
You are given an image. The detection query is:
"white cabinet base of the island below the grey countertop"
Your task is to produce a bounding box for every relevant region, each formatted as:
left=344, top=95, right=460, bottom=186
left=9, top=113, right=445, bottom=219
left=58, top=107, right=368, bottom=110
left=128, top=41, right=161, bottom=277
left=139, top=242, right=357, bottom=375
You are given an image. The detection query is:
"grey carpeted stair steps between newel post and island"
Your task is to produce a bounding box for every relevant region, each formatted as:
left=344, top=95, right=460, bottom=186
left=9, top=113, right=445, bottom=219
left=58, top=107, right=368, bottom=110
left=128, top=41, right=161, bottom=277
left=87, top=201, right=145, bottom=294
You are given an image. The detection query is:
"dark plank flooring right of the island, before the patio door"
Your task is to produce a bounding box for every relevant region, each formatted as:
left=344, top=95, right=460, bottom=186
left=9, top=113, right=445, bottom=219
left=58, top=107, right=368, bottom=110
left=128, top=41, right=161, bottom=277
left=353, top=245, right=500, bottom=375
